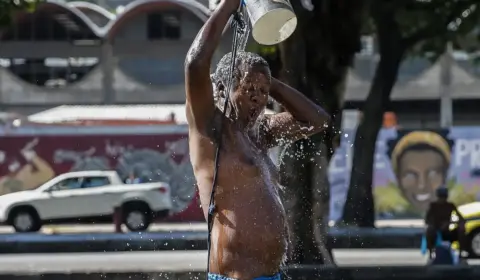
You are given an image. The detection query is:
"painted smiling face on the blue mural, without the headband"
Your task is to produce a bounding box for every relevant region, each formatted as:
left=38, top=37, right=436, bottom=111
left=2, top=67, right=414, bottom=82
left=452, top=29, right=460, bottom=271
left=397, top=150, right=446, bottom=210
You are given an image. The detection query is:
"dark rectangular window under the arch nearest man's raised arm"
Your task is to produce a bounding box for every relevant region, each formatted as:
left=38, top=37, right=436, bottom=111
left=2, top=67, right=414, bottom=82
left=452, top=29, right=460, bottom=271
left=147, top=12, right=181, bottom=40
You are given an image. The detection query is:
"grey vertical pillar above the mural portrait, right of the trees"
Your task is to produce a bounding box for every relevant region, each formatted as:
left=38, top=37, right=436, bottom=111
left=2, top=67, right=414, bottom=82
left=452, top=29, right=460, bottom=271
left=439, top=42, right=453, bottom=128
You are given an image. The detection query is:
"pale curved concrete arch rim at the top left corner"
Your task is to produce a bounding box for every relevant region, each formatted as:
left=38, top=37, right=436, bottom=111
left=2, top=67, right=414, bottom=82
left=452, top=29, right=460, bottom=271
left=0, top=0, right=101, bottom=40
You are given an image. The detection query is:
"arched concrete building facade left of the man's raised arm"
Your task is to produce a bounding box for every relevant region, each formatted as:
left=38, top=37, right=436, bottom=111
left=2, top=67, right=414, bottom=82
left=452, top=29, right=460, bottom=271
left=0, top=0, right=231, bottom=113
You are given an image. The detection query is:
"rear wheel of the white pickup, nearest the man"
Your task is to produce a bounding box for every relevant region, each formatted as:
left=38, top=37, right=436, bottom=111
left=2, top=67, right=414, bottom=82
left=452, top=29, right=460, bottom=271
left=122, top=202, right=152, bottom=232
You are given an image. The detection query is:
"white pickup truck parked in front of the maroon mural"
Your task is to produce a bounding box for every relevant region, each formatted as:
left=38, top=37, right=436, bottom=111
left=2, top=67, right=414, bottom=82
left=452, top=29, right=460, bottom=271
left=0, top=171, right=172, bottom=232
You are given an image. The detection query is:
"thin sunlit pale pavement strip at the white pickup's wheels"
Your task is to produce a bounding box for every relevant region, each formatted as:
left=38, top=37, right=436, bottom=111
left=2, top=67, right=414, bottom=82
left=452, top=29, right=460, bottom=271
left=0, top=220, right=424, bottom=234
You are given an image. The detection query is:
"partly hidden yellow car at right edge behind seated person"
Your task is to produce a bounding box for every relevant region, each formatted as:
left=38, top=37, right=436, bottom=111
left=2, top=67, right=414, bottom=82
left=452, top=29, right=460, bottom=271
left=450, top=202, right=480, bottom=258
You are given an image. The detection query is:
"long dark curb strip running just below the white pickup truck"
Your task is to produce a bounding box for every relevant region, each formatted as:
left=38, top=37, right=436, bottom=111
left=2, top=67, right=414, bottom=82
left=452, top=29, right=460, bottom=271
left=0, top=229, right=421, bottom=254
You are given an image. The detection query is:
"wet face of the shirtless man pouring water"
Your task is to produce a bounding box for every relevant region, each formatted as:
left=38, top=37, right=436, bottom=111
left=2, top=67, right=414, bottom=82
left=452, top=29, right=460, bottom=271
left=231, top=66, right=270, bottom=125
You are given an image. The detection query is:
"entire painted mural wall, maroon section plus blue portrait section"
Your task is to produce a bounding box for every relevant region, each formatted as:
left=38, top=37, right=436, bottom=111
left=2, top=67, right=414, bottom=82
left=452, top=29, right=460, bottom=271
left=0, top=127, right=480, bottom=221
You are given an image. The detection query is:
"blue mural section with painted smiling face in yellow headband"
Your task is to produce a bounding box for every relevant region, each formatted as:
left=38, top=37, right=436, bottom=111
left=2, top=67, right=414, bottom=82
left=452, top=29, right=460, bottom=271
left=330, top=127, right=480, bottom=220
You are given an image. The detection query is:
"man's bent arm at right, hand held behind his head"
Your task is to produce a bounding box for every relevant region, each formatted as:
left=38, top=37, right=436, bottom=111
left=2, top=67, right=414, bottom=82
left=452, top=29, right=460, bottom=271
left=263, top=78, right=330, bottom=148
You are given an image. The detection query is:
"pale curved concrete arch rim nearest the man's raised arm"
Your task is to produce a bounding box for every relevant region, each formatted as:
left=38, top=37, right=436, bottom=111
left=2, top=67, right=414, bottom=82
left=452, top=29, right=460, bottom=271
left=104, top=0, right=210, bottom=41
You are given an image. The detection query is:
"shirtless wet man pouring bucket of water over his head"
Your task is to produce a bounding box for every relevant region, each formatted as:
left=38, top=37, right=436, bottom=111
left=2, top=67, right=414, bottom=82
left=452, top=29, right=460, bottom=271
left=185, top=0, right=329, bottom=280
